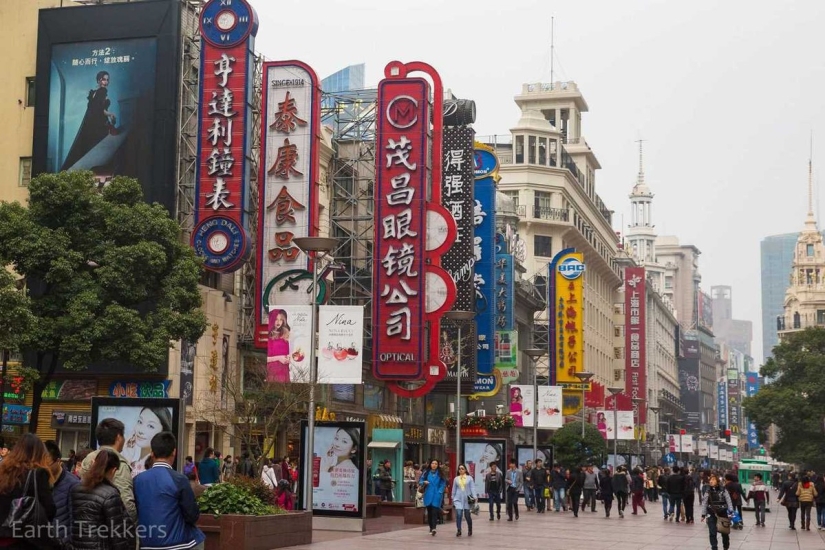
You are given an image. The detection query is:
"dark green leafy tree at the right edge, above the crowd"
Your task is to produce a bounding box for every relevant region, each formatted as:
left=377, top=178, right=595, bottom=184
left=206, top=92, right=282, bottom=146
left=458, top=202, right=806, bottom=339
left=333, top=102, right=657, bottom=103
left=742, top=327, right=825, bottom=470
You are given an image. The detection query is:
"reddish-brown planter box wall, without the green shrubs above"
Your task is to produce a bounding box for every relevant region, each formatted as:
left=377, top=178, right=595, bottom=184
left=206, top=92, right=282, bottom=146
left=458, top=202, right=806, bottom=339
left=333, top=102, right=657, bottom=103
left=198, top=512, right=312, bottom=550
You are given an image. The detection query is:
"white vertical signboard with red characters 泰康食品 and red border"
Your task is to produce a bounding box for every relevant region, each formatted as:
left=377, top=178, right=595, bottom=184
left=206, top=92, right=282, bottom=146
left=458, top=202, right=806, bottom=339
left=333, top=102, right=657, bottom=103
left=256, top=61, right=320, bottom=346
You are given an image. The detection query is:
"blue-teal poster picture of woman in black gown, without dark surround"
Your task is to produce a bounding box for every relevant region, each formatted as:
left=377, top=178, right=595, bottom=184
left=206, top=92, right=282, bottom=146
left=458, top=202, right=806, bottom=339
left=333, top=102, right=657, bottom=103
left=46, top=38, right=157, bottom=182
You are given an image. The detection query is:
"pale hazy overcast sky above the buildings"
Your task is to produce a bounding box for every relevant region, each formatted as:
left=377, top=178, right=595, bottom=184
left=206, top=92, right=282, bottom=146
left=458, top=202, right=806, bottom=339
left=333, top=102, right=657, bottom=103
left=254, top=0, right=825, bottom=370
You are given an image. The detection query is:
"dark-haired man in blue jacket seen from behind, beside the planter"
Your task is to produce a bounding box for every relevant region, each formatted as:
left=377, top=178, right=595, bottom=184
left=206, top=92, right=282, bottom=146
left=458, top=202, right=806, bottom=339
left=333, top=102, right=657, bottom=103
left=135, top=432, right=206, bottom=550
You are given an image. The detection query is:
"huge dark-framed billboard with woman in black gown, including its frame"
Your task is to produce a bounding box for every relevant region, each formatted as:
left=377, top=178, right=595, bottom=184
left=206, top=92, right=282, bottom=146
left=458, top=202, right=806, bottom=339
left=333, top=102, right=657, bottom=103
left=33, top=2, right=180, bottom=212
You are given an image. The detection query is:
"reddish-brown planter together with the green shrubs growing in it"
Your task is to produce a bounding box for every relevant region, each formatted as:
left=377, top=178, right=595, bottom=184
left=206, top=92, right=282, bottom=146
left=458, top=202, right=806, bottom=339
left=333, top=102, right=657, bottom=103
left=198, top=478, right=312, bottom=550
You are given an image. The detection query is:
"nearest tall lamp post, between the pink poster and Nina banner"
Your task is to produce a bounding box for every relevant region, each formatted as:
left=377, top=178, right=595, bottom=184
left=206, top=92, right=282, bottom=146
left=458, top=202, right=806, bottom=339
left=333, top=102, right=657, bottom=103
left=292, top=237, right=338, bottom=512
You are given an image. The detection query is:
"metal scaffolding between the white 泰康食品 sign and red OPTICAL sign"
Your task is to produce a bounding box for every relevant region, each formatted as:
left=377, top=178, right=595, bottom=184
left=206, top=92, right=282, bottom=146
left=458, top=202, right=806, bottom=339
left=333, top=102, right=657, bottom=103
left=321, top=90, right=377, bottom=344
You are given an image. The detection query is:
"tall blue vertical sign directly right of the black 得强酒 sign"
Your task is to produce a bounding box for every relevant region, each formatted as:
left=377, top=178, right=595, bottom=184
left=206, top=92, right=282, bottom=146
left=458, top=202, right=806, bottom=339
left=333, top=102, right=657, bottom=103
left=473, top=143, right=498, bottom=382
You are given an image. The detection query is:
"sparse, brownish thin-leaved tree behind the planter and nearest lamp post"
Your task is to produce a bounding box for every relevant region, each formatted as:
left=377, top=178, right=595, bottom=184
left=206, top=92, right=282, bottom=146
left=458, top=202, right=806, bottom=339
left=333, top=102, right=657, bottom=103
left=195, top=357, right=310, bottom=467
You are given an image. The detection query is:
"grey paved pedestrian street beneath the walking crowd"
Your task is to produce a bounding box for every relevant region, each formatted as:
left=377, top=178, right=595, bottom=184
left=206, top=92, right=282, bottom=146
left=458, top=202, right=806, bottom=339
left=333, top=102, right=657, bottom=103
left=294, top=502, right=825, bottom=550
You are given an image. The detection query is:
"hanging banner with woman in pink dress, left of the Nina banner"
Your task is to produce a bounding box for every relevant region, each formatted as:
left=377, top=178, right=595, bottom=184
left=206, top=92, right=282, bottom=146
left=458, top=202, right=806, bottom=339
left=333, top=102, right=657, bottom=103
left=266, top=305, right=312, bottom=383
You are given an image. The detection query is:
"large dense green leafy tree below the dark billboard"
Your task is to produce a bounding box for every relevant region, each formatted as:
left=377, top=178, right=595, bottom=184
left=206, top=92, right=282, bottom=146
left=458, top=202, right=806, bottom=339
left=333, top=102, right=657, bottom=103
left=0, top=172, right=206, bottom=430
